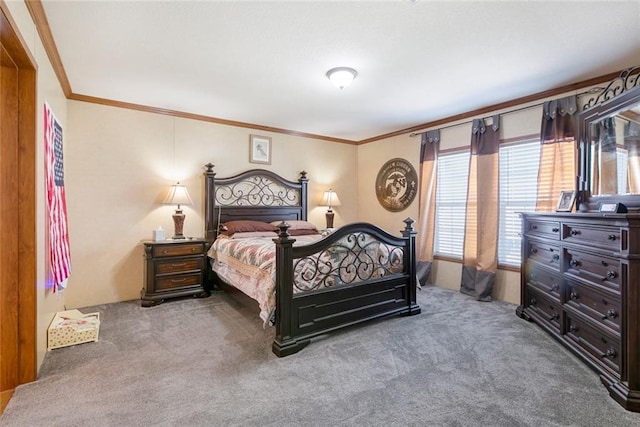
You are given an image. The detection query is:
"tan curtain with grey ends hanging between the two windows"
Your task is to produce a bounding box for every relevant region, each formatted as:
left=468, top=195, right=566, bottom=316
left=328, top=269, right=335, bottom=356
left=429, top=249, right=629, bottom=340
left=460, top=116, right=500, bottom=301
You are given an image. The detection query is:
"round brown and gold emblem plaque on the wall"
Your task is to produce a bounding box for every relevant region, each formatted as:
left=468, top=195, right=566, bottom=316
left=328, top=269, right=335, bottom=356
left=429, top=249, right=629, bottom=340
left=376, top=159, right=419, bottom=212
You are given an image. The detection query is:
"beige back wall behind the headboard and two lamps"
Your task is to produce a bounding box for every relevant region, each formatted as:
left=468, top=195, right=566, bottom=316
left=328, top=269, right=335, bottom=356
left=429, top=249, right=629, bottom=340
left=65, top=101, right=358, bottom=308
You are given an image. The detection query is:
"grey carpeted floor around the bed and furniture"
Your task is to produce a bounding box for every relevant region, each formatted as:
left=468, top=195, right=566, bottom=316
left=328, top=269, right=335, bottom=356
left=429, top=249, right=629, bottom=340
left=0, top=287, right=640, bottom=427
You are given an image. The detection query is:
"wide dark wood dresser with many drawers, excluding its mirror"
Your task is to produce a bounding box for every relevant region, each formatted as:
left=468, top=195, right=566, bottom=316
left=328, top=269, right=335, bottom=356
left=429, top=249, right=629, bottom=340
left=516, top=213, right=640, bottom=412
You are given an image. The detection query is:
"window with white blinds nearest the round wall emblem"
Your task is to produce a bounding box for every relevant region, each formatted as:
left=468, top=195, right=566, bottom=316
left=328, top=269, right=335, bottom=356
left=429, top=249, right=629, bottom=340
left=434, top=149, right=469, bottom=258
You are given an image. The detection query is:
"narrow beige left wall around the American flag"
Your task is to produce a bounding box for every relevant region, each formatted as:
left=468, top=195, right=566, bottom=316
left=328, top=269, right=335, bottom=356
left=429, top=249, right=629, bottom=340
left=7, top=1, right=67, bottom=366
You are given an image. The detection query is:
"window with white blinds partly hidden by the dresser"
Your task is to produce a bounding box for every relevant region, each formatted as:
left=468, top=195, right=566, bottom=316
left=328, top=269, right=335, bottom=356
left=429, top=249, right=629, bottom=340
left=498, top=139, right=540, bottom=266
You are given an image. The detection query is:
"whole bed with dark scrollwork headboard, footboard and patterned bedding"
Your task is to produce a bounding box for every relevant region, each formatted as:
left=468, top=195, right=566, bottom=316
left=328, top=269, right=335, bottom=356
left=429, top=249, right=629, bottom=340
left=205, top=163, right=420, bottom=357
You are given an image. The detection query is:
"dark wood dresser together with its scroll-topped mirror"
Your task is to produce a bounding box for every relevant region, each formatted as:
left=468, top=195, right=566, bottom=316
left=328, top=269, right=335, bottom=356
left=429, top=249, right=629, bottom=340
left=516, top=67, right=640, bottom=412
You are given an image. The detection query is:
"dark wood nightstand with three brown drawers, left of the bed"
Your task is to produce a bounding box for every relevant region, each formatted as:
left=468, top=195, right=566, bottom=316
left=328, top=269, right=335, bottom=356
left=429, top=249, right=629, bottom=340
left=140, top=239, right=208, bottom=307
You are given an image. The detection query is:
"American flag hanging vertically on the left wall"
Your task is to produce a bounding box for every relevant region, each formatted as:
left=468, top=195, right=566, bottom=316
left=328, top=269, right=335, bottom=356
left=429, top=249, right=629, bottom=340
left=44, top=103, right=71, bottom=292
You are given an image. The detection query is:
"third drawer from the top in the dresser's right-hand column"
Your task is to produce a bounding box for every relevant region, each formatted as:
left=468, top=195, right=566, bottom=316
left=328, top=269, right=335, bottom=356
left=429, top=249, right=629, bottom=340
left=565, top=280, right=621, bottom=334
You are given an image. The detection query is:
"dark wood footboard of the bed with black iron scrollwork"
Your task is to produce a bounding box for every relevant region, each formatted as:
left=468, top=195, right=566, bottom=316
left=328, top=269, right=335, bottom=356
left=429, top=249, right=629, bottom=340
left=272, top=218, right=420, bottom=357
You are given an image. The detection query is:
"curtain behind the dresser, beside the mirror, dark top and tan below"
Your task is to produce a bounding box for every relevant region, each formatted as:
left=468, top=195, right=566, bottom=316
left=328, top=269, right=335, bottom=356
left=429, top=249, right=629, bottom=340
left=536, top=95, right=578, bottom=212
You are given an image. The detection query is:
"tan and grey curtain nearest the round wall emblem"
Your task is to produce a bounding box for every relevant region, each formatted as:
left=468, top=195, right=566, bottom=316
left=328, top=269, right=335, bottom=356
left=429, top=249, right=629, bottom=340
left=417, top=129, right=440, bottom=285
